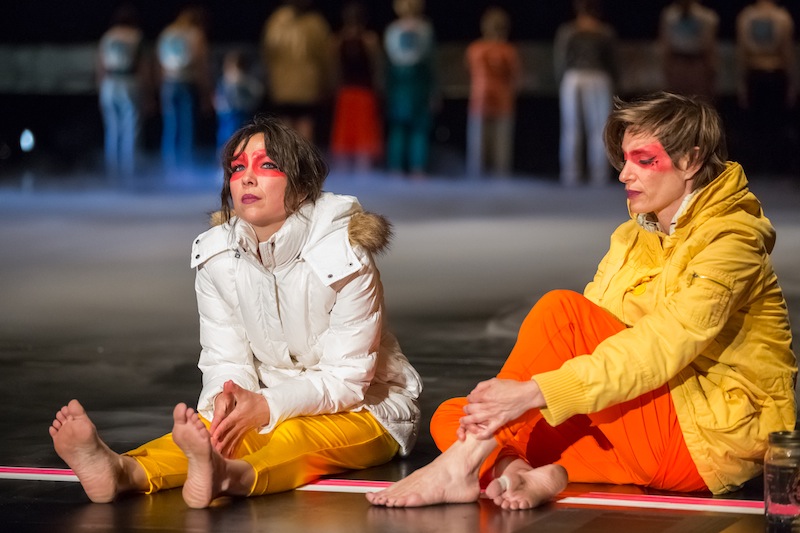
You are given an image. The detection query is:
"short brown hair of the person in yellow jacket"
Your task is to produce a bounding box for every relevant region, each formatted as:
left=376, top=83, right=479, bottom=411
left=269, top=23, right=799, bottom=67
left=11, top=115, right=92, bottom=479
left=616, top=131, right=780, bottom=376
left=603, top=92, right=728, bottom=190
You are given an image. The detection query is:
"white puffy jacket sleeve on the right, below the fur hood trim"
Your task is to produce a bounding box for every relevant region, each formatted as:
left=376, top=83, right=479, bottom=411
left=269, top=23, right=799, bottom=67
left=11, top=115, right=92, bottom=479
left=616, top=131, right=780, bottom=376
left=261, top=247, right=383, bottom=433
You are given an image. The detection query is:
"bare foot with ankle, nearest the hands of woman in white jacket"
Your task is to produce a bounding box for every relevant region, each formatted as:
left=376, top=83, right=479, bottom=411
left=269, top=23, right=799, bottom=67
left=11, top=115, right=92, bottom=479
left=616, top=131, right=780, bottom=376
left=172, top=403, right=255, bottom=509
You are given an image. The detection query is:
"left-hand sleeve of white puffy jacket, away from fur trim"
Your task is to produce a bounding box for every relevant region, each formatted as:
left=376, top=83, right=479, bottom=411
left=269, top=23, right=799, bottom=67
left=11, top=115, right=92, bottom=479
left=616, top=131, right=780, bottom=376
left=195, top=257, right=260, bottom=420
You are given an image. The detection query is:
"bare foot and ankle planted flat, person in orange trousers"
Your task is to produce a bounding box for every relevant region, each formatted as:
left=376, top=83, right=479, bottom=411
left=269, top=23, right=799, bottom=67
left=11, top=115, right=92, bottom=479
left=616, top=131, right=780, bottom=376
left=367, top=435, right=498, bottom=507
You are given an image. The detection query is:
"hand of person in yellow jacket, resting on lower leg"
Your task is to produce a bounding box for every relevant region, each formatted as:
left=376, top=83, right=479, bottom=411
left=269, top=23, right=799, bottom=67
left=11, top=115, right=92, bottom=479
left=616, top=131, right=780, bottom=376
left=458, top=378, right=545, bottom=440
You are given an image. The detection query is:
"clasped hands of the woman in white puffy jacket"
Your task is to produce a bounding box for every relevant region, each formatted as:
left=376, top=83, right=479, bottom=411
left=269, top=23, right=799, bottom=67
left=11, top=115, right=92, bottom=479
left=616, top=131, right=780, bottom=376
left=209, top=381, right=270, bottom=458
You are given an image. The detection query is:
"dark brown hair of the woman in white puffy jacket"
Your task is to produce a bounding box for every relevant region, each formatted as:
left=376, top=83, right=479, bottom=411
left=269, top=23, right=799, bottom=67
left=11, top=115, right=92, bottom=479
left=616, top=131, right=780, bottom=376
left=220, top=115, right=328, bottom=221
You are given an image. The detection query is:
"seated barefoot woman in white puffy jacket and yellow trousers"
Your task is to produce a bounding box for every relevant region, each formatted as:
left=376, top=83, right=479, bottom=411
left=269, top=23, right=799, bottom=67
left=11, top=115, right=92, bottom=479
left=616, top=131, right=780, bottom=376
left=50, top=117, right=422, bottom=507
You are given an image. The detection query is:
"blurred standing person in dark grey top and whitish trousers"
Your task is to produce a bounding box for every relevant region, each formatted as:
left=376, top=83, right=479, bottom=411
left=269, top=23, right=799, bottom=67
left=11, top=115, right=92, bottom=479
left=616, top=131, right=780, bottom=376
left=553, top=0, right=617, bottom=186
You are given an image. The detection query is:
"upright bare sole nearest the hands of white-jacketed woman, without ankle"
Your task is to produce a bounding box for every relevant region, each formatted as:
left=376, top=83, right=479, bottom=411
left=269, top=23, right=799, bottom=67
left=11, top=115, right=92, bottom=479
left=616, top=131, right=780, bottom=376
left=172, top=403, right=225, bottom=509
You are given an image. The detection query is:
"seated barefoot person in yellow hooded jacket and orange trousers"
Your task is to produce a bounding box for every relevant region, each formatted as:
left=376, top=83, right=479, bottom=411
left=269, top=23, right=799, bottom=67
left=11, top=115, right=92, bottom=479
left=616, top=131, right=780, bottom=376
left=367, top=93, right=797, bottom=509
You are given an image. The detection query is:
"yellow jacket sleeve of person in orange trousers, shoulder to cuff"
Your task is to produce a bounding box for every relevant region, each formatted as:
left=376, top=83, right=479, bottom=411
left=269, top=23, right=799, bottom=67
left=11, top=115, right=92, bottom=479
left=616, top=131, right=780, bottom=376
left=533, top=225, right=765, bottom=425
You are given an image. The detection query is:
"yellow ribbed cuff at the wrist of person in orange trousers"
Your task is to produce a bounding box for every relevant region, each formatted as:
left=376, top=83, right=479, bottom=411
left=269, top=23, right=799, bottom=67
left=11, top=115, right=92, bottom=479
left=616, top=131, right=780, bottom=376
left=532, top=366, right=589, bottom=426
